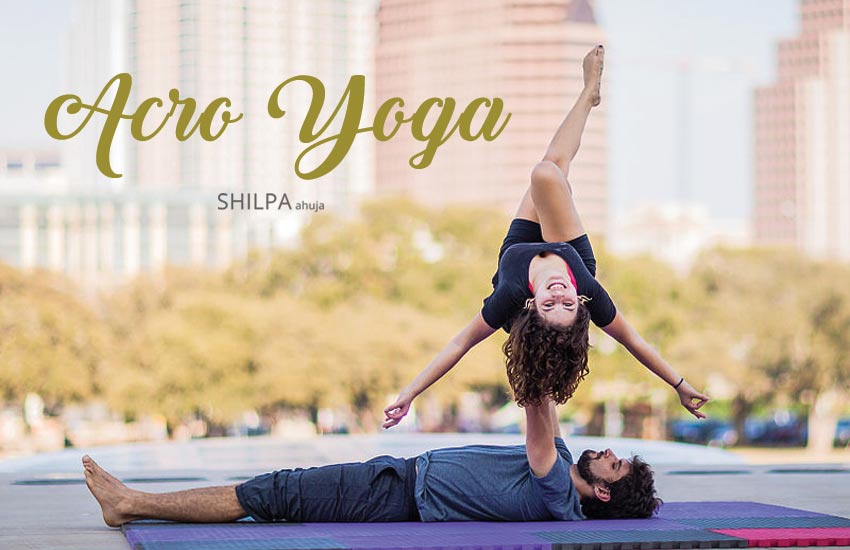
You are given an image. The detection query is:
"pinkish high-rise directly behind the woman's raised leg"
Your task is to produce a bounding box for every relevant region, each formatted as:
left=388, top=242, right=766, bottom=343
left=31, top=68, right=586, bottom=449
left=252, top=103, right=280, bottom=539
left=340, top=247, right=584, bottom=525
left=376, top=0, right=608, bottom=233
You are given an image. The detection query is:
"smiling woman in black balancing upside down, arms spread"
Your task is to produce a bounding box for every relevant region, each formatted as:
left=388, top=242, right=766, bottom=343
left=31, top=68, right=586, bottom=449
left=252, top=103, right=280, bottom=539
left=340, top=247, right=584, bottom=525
left=383, top=46, right=708, bottom=428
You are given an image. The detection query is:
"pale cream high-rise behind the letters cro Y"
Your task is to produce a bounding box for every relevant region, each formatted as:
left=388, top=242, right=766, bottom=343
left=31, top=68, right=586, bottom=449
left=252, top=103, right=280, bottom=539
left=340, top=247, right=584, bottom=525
left=128, top=0, right=374, bottom=207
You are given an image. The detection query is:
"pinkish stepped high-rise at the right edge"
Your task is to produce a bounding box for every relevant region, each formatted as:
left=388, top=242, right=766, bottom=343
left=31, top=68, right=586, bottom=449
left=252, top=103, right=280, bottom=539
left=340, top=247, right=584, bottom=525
left=753, top=0, right=850, bottom=260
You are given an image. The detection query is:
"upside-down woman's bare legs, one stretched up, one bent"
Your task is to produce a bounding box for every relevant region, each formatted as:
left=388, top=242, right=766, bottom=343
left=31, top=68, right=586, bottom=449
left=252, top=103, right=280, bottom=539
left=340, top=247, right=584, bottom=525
left=516, top=46, right=605, bottom=242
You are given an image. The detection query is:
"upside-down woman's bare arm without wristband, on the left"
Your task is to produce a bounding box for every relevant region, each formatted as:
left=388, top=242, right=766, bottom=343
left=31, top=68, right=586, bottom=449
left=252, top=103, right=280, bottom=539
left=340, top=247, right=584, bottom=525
left=383, top=311, right=496, bottom=428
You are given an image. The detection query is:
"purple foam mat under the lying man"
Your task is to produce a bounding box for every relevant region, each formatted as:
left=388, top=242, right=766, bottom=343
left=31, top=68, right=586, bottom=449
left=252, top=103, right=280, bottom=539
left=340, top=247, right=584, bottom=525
left=124, top=502, right=844, bottom=550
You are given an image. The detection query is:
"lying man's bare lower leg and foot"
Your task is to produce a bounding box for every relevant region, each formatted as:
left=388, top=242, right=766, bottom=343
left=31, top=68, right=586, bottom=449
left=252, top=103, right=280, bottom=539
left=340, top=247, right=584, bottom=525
left=83, top=455, right=247, bottom=527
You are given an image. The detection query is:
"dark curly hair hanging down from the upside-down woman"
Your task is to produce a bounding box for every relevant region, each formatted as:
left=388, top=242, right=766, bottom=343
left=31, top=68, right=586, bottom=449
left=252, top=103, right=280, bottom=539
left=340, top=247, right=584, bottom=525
left=502, top=302, right=590, bottom=406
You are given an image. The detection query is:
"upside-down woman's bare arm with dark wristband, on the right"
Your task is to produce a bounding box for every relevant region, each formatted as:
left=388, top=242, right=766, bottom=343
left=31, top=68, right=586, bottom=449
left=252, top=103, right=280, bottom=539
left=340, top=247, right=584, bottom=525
left=602, top=311, right=709, bottom=418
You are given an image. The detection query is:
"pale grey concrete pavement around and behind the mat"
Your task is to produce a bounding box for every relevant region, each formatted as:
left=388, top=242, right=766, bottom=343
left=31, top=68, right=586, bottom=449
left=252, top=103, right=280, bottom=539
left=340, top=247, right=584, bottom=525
left=0, top=434, right=850, bottom=550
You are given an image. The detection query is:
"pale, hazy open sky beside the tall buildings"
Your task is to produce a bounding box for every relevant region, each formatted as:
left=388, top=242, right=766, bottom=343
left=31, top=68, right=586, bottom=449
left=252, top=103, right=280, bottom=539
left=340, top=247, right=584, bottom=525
left=0, top=0, right=799, bottom=221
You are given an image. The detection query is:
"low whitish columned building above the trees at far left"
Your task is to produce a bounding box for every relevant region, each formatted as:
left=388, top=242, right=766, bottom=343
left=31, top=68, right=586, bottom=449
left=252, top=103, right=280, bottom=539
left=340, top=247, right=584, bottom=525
left=0, top=149, right=222, bottom=289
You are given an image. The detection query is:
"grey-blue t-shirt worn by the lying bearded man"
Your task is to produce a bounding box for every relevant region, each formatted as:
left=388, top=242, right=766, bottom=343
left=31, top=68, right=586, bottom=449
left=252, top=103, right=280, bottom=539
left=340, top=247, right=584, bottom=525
left=415, top=437, right=585, bottom=521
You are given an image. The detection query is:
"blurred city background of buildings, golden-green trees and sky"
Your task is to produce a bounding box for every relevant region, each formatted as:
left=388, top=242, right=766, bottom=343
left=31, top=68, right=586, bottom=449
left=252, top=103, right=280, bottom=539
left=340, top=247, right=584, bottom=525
left=0, top=0, right=850, bottom=459
